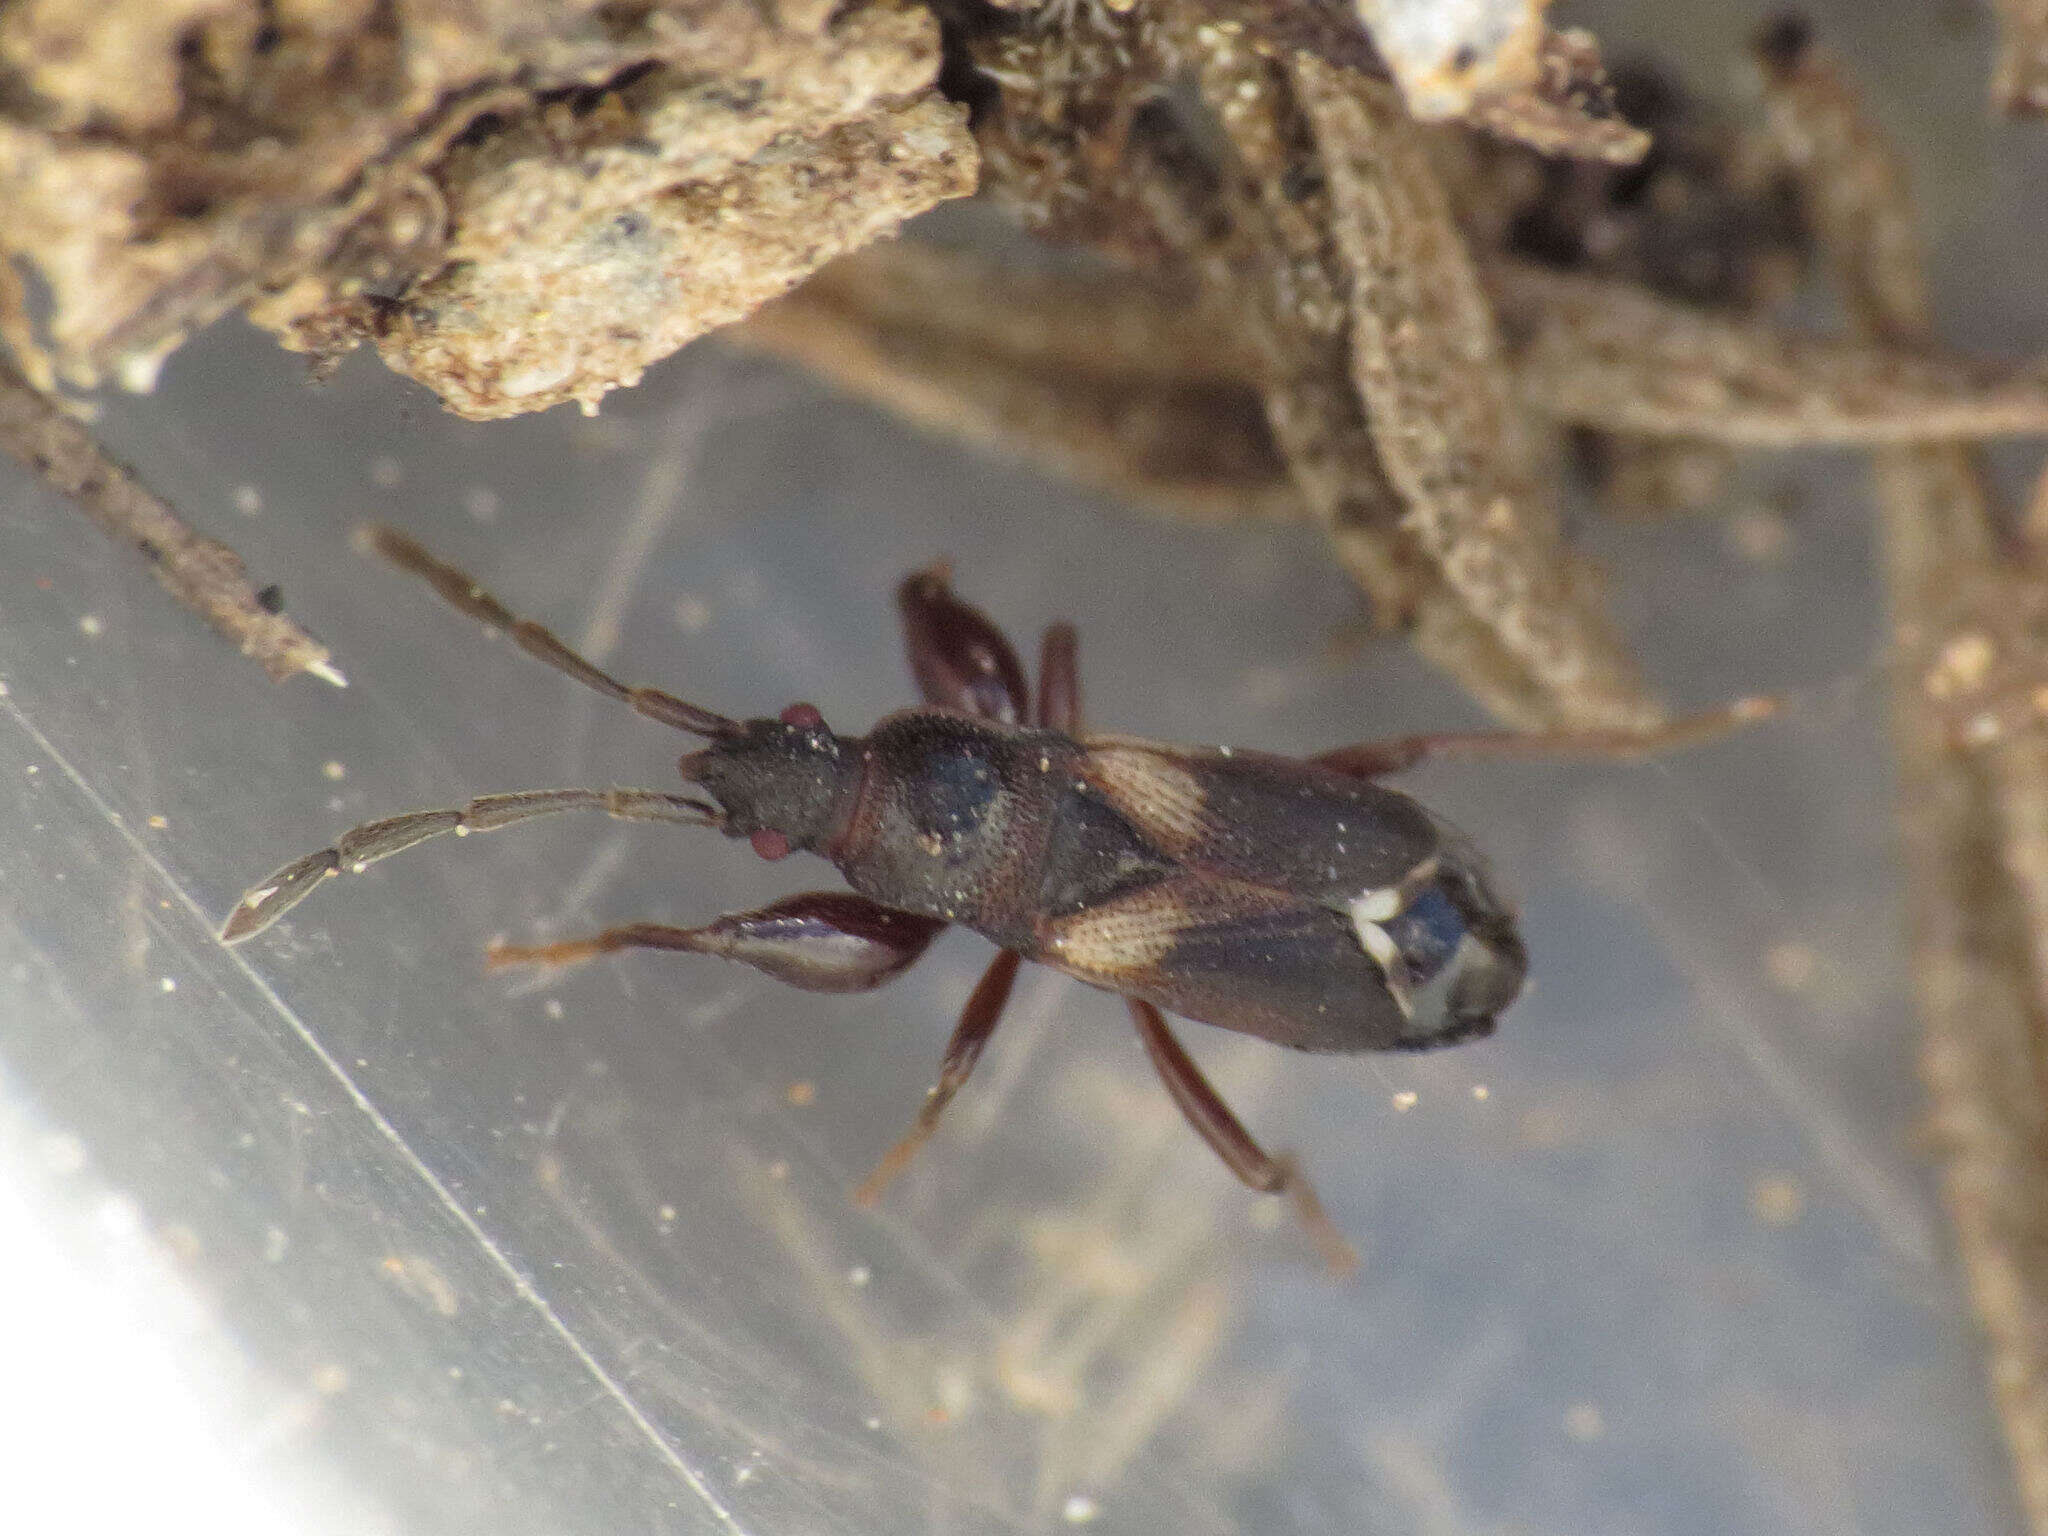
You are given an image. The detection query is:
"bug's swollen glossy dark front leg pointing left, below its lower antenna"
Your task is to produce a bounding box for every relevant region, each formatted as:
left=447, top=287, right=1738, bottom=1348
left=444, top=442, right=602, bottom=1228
left=485, top=891, right=946, bottom=991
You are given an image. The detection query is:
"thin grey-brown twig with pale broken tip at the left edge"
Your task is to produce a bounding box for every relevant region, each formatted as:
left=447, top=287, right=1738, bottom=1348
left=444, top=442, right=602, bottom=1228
left=0, top=358, right=346, bottom=686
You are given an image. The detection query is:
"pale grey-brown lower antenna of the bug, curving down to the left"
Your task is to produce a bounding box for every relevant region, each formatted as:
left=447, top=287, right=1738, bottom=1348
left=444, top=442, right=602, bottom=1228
left=221, top=788, right=725, bottom=944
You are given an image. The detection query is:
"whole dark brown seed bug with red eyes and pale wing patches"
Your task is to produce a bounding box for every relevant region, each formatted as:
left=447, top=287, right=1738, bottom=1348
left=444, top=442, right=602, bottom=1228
left=221, top=528, right=1763, bottom=1268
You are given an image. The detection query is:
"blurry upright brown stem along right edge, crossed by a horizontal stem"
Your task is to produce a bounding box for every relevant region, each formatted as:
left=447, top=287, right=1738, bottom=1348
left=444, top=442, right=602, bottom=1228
left=1759, top=25, right=2048, bottom=1532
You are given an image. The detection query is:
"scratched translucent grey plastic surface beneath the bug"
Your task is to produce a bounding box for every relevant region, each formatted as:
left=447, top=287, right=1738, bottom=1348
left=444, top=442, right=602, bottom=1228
left=0, top=8, right=2048, bottom=1536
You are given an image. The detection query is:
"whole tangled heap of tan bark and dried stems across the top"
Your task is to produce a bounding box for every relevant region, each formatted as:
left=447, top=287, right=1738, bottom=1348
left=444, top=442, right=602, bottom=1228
left=24, top=0, right=2044, bottom=749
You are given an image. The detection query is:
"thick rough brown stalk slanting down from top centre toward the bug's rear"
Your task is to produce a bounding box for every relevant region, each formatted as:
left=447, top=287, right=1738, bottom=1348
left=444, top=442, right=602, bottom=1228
left=973, top=6, right=1659, bottom=727
